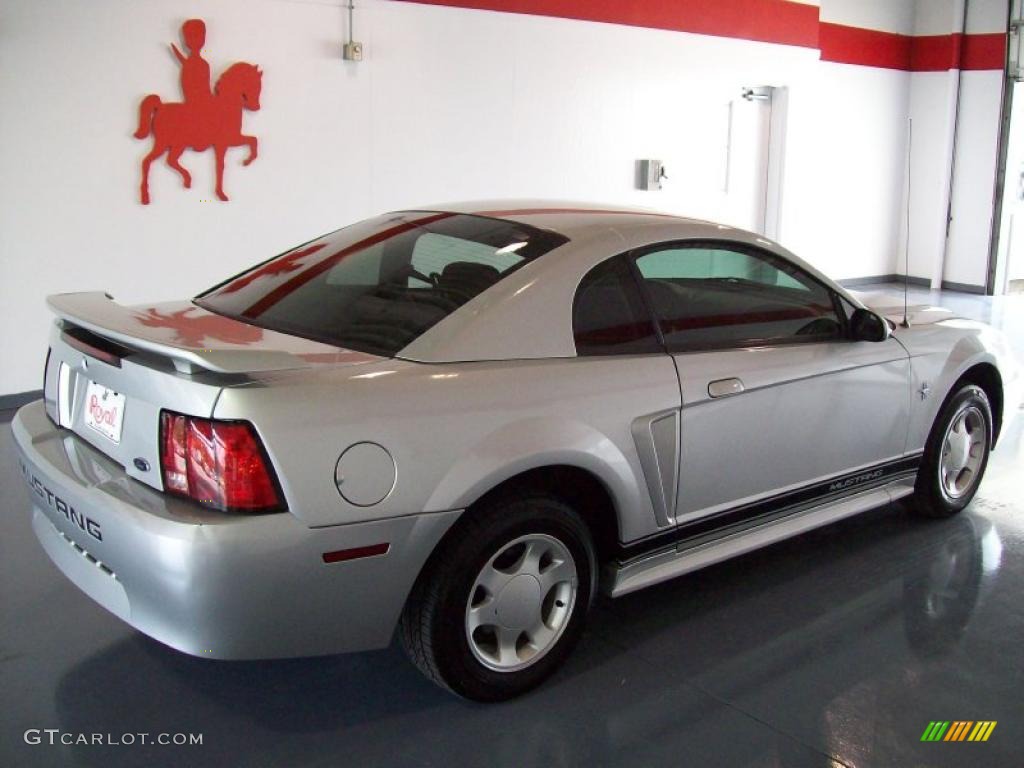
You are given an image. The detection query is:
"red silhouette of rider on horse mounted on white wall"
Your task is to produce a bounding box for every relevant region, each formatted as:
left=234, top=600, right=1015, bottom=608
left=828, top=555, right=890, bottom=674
left=135, top=18, right=263, bottom=205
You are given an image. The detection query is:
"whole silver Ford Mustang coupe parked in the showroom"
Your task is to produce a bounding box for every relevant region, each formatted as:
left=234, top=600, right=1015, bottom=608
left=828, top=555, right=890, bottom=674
left=13, top=202, right=1022, bottom=700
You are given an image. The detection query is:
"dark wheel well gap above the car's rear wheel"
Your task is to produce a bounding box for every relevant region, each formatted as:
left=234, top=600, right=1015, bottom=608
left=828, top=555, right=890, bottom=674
left=466, top=465, right=618, bottom=563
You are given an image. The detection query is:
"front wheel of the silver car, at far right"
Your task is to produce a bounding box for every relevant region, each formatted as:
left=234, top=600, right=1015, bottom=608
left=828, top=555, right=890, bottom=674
left=912, top=384, right=992, bottom=517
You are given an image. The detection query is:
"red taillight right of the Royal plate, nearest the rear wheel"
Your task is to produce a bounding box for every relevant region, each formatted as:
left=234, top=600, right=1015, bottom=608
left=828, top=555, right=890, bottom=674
left=160, top=411, right=284, bottom=512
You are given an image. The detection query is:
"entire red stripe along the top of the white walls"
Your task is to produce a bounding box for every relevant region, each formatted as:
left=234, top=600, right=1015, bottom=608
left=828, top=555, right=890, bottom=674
left=402, top=0, right=1007, bottom=72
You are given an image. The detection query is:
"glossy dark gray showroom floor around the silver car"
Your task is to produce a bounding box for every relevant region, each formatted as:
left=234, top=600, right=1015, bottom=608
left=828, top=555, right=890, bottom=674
left=0, top=291, right=1024, bottom=768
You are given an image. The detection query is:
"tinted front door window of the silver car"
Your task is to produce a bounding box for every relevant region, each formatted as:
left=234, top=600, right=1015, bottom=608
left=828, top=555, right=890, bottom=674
left=637, top=245, right=843, bottom=349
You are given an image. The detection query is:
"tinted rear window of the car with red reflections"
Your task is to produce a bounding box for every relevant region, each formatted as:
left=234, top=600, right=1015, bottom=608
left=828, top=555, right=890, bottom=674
left=195, top=211, right=567, bottom=356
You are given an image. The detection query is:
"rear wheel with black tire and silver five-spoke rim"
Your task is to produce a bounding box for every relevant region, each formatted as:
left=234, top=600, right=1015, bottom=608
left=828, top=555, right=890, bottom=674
left=398, top=493, right=597, bottom=701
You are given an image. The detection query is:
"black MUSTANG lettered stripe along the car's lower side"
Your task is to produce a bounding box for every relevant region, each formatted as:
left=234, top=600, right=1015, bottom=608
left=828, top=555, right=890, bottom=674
left=616, top=454, right=922, bottom=564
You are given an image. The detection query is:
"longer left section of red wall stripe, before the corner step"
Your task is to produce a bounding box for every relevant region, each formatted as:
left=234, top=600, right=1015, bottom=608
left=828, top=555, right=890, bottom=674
left=395, top=0, right=818, bottom=48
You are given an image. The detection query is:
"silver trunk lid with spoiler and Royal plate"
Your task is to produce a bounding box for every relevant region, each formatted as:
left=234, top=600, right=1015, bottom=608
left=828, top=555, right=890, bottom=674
left=44, top=292, right=381, bottom=489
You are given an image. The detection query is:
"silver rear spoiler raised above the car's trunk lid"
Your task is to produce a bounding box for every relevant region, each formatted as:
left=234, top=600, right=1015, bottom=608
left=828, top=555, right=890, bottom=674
left=46, top=291, right=309, bottom=374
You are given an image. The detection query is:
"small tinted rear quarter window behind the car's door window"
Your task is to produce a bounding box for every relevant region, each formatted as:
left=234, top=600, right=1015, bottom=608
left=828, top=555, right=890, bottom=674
left=572, top=257, right=663, bottom=355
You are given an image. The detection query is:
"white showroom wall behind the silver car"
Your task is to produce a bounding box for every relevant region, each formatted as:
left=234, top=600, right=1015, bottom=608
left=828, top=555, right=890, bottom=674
left=0, top=0, right=1006, bottom=395
